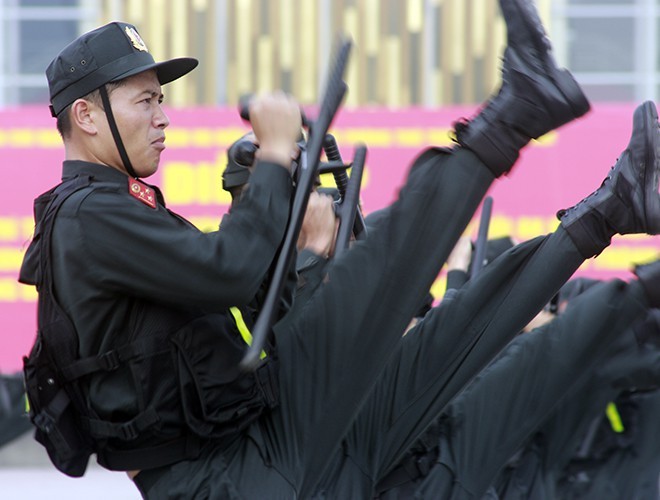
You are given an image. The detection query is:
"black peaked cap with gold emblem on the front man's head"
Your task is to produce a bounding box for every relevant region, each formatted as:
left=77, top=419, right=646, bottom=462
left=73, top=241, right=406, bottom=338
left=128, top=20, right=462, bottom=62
left=46, top=22, right=198, bottom=116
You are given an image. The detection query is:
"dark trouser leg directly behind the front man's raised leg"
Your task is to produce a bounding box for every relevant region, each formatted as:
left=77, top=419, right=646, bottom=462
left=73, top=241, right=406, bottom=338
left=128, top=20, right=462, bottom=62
left=323, top=228, right=583, bottom=498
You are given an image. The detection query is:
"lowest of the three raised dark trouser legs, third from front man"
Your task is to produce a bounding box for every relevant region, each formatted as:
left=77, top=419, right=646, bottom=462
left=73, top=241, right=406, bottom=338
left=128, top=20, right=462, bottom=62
left=416, top=280, right=648, bottom=499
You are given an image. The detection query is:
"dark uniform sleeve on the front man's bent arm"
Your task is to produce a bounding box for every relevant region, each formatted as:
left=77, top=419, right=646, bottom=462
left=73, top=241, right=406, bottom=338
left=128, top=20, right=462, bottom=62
left=58, top=163, right=291, bottom=310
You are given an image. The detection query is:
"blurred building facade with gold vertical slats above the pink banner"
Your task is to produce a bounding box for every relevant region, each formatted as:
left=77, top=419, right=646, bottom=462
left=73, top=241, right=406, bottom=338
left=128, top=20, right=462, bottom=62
left=0, top=0, right=660, bottom=107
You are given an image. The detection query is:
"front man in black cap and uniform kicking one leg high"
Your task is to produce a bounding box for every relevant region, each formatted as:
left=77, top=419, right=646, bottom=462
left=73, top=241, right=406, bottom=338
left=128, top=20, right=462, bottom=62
left=21, top=0, right=636, bottom=498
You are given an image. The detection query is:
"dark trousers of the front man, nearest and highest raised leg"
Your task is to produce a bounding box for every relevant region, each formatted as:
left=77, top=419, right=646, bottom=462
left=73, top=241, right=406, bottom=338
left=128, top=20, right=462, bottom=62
left=136, top=149, right=494, bottom=499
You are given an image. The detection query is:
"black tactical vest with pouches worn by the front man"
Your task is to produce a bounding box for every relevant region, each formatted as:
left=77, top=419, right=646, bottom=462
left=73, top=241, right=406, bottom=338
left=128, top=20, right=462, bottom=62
left=19, top=176, right=278, bottom=476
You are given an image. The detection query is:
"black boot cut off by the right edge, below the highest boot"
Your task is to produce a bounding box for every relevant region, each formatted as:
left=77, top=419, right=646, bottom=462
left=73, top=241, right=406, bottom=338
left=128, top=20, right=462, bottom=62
left=557, top=101, right=660, bottom=259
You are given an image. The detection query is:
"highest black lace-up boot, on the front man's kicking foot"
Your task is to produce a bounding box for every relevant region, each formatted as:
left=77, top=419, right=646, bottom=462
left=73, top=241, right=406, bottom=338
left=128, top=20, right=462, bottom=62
left=455, top=0, right=590, bottom=176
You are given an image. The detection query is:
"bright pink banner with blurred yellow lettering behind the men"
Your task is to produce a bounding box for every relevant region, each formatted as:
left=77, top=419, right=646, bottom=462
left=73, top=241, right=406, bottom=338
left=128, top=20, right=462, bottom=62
left=0, top=105, right=660, bottom=372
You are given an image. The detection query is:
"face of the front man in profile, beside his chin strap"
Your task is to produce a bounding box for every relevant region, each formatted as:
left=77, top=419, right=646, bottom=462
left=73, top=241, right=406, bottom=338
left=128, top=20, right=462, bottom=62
left=104, top=71, right=170, bottom=177
